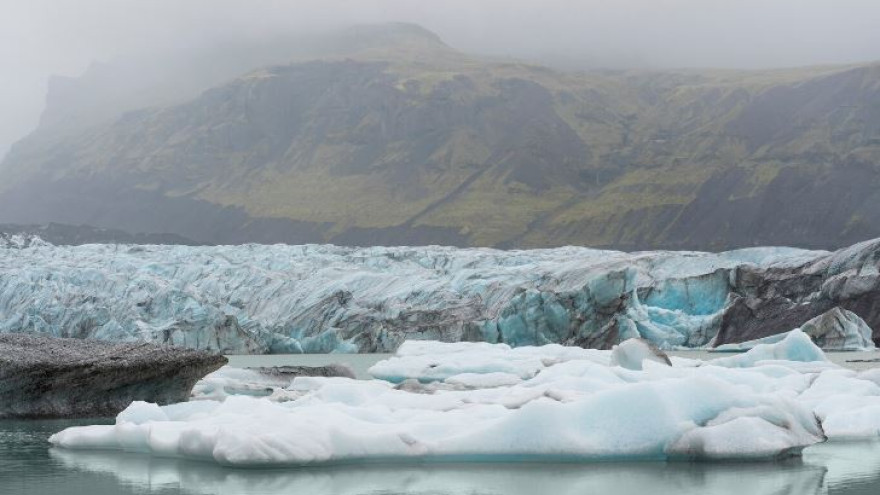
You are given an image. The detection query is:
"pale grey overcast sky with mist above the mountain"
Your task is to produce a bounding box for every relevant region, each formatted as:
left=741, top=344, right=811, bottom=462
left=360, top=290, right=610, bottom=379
left=0, top=0, right=880, bottom=156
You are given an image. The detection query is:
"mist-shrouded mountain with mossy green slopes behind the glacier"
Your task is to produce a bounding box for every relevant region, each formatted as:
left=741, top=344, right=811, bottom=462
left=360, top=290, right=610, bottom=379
left=0, top=24, right=880, bottom=250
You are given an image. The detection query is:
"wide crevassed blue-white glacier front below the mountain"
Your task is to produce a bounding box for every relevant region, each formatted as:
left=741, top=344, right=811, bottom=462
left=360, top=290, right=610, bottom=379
left=0, top=238, right=880, bottom=353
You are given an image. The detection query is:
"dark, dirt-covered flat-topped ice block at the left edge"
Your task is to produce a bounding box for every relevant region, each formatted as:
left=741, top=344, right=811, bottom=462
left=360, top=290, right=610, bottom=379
left=0, top=334, right=226, bottom=418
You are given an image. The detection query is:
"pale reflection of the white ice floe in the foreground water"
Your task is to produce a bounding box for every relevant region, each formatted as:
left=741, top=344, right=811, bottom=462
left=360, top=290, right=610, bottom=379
left=50, top=449, right=832, bottom=495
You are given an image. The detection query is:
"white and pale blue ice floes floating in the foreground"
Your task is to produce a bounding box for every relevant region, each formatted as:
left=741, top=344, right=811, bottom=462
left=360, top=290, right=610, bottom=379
left=50, top=331, right=852, bottom=466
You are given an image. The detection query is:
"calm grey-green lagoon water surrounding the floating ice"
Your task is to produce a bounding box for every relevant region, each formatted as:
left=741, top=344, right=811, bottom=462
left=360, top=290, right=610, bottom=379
left=0, top=354, right=880, bottom=495
